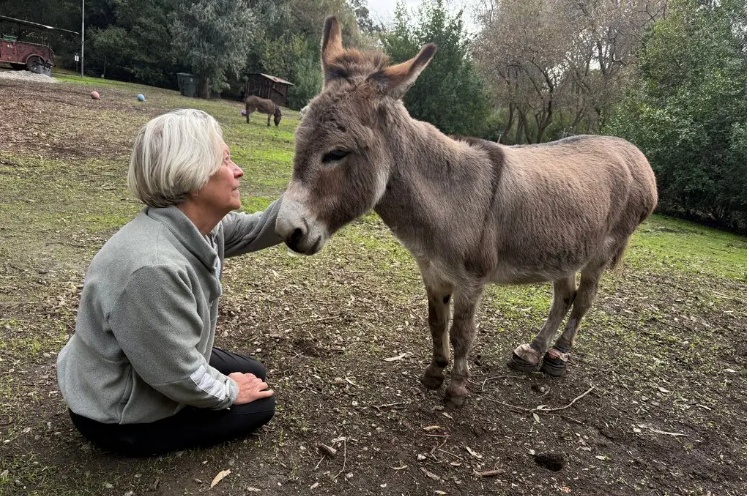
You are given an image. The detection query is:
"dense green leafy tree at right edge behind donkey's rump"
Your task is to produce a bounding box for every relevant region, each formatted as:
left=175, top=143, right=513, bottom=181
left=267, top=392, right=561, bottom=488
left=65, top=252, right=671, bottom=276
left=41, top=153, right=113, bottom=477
left=606, top=0, right=747, bottom=230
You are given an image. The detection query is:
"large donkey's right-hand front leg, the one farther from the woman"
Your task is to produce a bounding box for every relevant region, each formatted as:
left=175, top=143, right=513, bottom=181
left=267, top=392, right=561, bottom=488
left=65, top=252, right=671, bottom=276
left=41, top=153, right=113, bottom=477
left=445, top=286, right=483, bottom=406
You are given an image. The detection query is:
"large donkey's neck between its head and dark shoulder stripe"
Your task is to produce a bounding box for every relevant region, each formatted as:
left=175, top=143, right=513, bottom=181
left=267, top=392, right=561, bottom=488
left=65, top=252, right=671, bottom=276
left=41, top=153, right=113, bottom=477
left=375, top=110, right=498, bottom=254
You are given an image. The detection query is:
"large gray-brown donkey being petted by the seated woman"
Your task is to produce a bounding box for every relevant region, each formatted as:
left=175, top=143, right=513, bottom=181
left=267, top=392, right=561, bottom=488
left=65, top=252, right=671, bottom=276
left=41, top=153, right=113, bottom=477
left=276, top=17, right=657, bottom=406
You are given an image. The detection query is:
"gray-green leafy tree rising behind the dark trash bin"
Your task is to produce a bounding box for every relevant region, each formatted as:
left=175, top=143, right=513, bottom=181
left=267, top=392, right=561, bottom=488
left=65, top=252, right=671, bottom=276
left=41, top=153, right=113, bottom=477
left=172, top=0, right=256, bottom=98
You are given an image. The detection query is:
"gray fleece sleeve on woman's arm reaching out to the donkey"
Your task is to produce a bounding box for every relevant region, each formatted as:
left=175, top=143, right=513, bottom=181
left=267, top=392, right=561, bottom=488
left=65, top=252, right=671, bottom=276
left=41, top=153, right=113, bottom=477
left=221, top=197, right=283, bottom=257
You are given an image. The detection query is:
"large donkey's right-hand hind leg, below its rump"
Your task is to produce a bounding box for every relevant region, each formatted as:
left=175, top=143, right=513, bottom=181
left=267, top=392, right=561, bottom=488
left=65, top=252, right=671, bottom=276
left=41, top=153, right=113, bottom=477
left=541, top=263, right=608, bottom=377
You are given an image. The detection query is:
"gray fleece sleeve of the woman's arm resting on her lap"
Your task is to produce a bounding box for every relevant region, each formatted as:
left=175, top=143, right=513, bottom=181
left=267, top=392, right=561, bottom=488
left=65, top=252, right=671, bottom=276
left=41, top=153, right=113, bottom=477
left=109, top=265, right=239, bottom=410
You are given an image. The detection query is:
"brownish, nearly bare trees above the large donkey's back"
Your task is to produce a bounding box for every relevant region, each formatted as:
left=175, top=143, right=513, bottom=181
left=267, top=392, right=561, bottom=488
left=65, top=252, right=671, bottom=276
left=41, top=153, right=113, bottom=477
left=474, top=0, right=664, bottom=143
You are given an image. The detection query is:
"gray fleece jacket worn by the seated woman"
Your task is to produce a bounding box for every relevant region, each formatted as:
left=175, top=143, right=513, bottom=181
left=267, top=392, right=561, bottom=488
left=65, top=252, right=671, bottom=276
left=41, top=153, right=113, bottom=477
left=57, top=200, right=281, bottom=424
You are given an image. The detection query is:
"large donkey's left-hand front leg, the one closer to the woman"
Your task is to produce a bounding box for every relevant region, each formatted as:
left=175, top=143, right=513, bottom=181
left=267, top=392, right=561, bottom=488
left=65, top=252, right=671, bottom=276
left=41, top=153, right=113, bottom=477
left=420, top=268, right=453, bottom=389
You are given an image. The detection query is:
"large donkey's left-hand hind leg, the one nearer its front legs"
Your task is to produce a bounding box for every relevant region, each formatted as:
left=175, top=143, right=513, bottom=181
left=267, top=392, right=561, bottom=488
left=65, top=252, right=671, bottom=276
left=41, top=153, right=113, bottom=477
left=507, top=274, right=575, bottom=372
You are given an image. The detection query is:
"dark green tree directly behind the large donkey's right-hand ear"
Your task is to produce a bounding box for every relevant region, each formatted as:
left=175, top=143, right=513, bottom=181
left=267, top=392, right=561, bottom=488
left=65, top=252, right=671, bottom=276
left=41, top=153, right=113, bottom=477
left=381, top=0, right=490, bottom=136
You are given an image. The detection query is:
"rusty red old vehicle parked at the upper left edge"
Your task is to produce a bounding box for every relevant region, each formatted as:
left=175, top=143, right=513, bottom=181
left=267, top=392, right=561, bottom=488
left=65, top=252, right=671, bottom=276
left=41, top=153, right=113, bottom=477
left=0, top=15, right=78, bottom=76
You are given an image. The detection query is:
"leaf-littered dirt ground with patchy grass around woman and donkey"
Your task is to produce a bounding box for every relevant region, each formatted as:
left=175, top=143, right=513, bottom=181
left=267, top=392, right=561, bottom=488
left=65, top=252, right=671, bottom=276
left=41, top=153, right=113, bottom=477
left=0, top=71, right=747, bottom=496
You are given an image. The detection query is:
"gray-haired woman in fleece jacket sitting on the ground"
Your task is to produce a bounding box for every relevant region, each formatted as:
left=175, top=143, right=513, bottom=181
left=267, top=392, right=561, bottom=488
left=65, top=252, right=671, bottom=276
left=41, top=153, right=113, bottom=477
left=57, top=110, right=281, bottom=455
